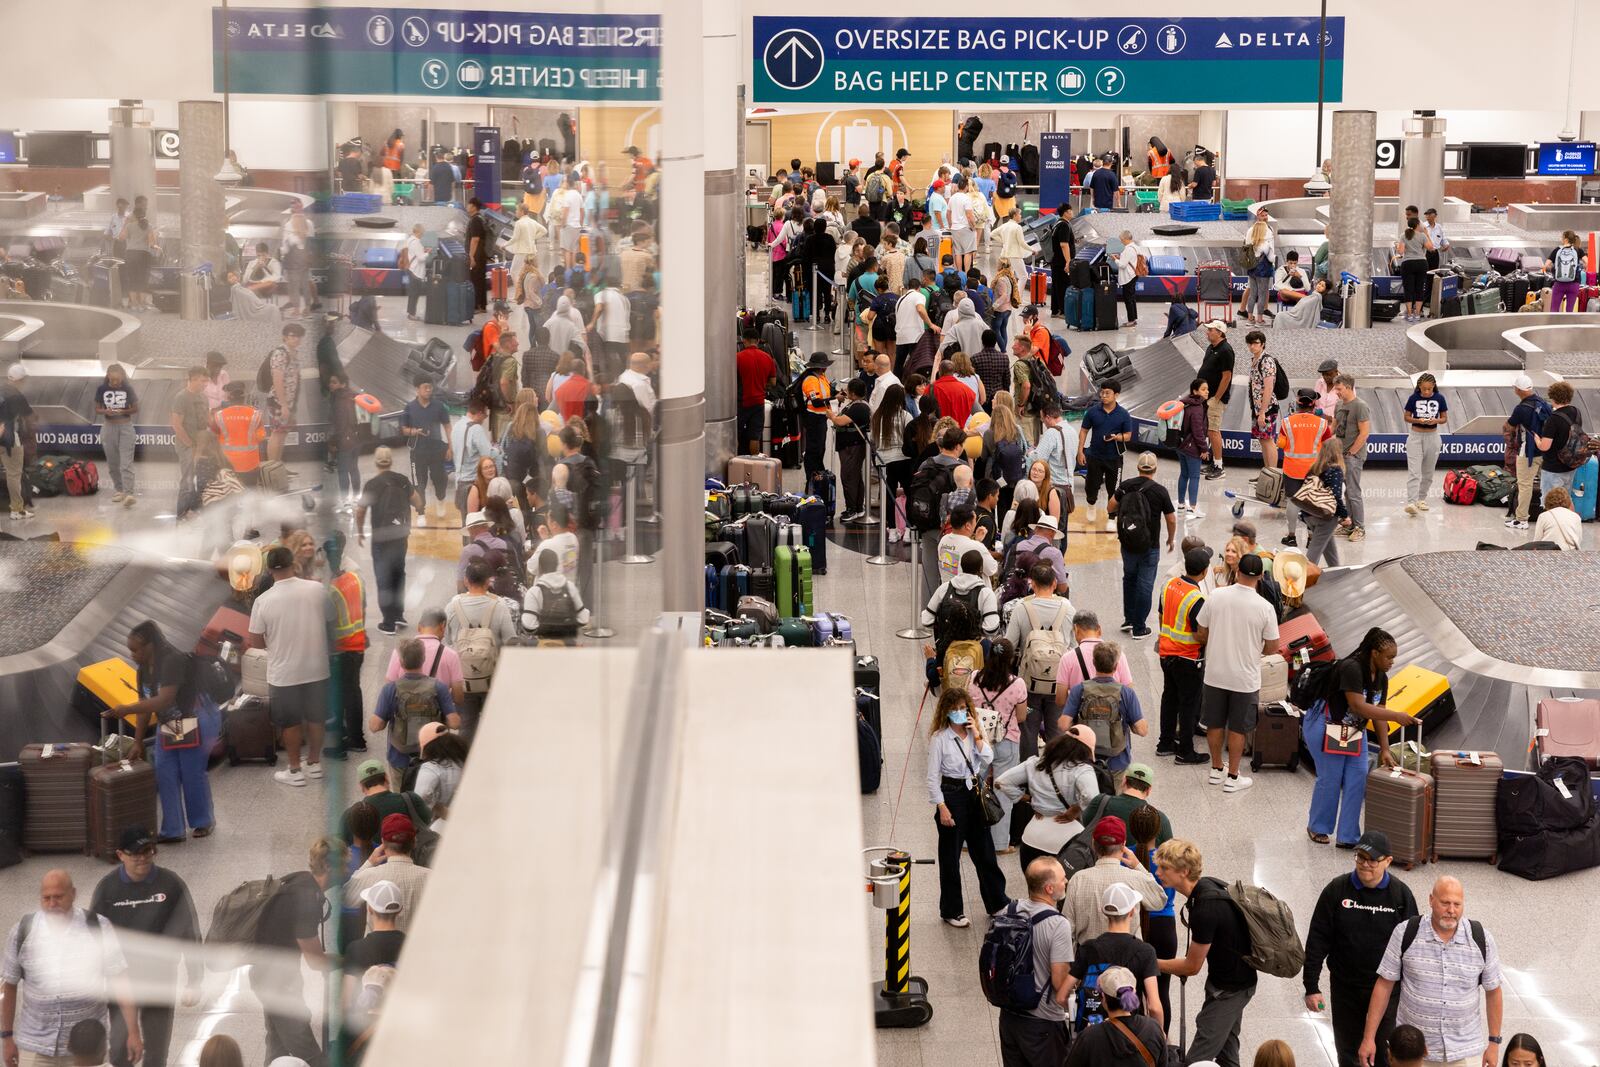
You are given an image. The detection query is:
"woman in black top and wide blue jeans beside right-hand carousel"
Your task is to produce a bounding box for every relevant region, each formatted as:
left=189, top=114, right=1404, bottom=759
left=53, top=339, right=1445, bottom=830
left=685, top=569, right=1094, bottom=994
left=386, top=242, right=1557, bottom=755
left=1294, top=625, right=1418, bottom=848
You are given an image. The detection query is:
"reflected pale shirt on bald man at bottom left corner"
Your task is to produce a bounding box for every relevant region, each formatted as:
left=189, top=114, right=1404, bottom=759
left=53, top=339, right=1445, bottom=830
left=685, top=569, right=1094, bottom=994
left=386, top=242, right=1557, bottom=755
left=0, top=907, right=128, bottom=1056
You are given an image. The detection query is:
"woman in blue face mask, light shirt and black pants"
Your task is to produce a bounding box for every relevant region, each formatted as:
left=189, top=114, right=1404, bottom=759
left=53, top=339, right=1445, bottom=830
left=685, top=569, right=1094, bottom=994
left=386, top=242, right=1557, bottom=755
left=928, top=688, right=1008, bottom=926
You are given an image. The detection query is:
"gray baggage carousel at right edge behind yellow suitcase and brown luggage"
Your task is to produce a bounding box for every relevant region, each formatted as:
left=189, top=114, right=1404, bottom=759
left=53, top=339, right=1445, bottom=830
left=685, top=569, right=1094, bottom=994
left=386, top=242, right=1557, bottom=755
left=1306, top=552, right=1600, bottom=758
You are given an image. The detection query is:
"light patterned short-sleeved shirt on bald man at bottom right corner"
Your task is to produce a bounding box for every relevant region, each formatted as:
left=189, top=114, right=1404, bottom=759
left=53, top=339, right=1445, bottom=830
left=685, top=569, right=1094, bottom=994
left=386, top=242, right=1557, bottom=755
left=1378, top=915, right=1501, bottom=1062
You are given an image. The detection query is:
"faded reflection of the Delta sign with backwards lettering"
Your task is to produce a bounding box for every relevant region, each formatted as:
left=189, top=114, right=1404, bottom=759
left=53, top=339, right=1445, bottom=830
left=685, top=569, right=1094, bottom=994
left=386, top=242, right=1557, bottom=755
left=211, top=6, right=661, bottom=101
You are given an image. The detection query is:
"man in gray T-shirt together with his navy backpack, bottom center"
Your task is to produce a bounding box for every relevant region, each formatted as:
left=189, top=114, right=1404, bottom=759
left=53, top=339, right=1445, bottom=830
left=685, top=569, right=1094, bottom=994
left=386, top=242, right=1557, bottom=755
left=979, top=856, right=1072, bottom=1067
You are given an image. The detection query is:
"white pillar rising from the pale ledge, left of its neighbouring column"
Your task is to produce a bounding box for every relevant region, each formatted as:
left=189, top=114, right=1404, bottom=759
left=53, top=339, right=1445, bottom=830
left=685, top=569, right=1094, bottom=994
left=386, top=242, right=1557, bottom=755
left=656, top=0, right=710, bottom=613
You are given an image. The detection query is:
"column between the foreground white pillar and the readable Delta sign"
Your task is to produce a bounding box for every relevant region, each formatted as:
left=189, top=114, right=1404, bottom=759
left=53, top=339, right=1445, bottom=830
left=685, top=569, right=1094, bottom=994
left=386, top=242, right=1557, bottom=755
left=701, top=3, right=744, bottom=477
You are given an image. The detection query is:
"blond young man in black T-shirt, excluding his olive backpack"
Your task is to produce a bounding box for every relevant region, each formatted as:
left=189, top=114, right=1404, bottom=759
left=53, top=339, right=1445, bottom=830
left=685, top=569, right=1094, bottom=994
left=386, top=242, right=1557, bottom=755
left=1155, top=837, right=1256, bottom=1067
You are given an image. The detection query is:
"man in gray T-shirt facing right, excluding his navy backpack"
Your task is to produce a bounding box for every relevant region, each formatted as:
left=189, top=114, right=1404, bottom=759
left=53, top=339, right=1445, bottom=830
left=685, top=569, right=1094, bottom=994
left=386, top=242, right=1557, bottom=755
left=1000, top=856, right=1072, bottom=1067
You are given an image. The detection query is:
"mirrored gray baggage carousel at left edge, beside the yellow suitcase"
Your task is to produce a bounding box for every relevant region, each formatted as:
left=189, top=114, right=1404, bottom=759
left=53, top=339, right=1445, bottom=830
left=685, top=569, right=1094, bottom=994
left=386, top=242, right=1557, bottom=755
left=0, top=541, right=232, bottom=761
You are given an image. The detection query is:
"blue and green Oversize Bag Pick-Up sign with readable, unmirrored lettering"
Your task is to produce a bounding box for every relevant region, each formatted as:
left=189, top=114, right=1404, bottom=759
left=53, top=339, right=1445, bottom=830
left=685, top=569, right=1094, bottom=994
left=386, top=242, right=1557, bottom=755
left=750, top=16, right=1344, bottom=107
